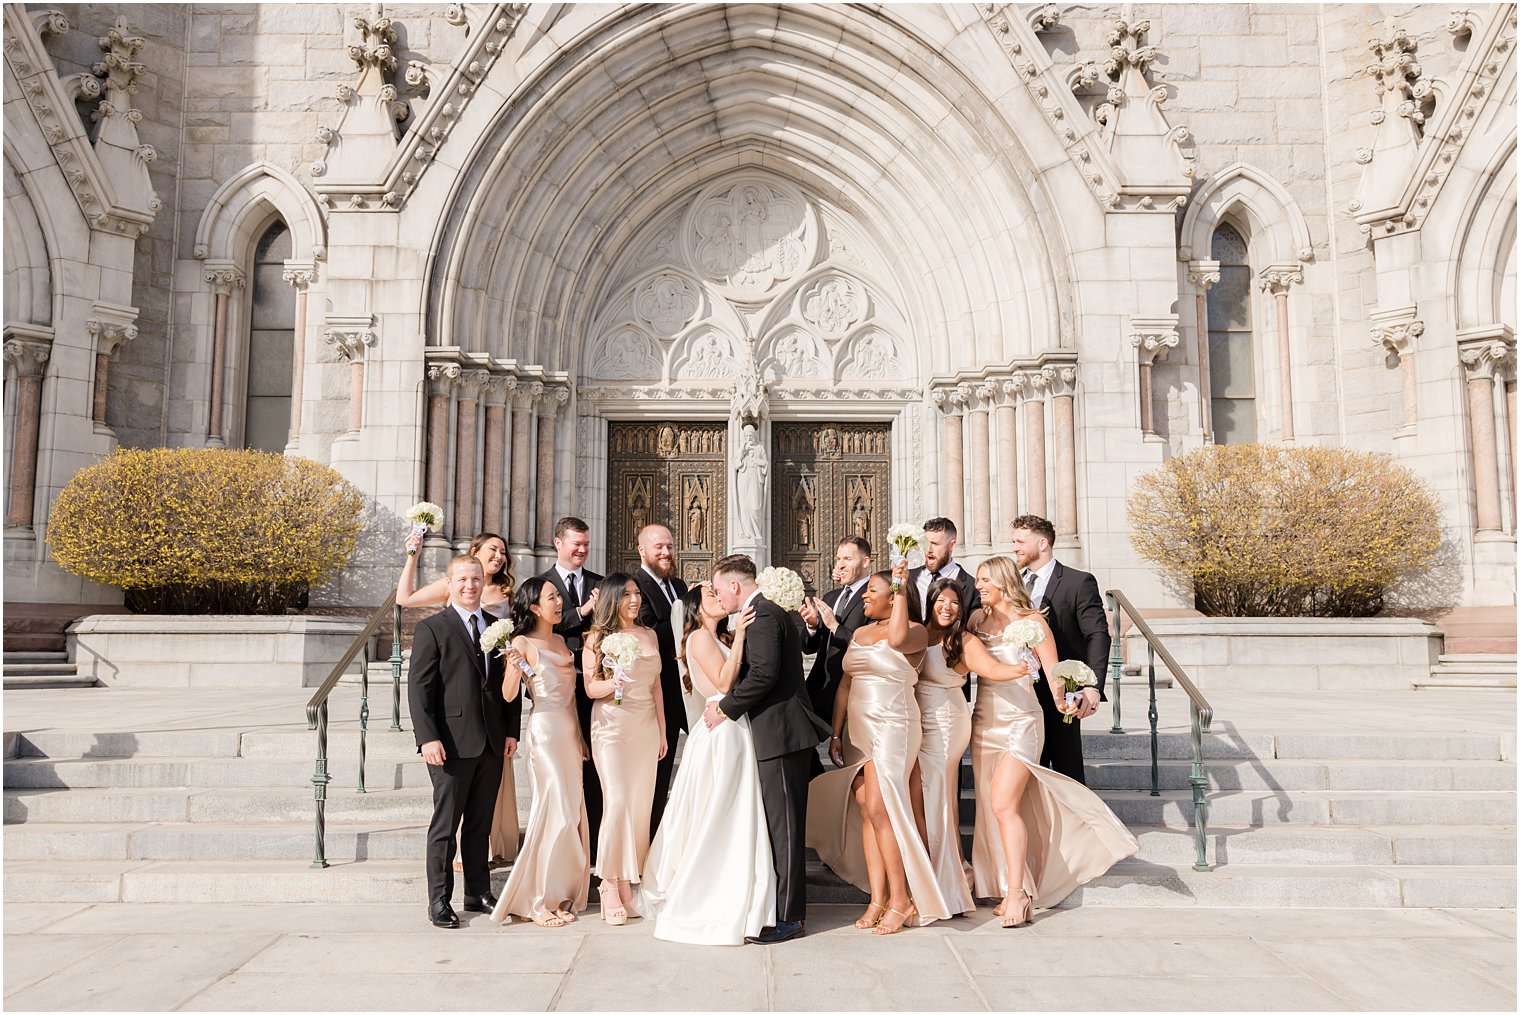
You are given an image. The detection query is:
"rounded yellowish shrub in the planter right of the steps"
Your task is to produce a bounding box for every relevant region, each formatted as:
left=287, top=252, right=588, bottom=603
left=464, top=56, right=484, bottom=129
left=1129, top=444, right=1441, bottom=617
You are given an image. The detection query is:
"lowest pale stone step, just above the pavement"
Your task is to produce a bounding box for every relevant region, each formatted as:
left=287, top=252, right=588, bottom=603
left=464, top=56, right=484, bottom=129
left=5, top=860, right=1515, bottom=909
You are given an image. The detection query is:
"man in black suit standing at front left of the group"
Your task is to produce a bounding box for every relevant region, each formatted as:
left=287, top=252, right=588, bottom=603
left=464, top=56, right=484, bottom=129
left=407, top=555, right=523, bottom=928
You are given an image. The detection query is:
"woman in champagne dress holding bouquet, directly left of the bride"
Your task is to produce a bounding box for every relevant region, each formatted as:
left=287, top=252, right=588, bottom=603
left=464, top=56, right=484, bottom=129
left=582, top=573, right=666, bottom=927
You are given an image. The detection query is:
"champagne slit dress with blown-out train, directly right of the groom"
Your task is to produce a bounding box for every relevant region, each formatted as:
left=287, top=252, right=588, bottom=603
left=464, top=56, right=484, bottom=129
left=807, top=640, right=950, bottom=924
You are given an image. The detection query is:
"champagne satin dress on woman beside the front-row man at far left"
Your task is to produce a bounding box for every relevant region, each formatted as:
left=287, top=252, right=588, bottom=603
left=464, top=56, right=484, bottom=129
left=491, top=646, right=591, bottom=924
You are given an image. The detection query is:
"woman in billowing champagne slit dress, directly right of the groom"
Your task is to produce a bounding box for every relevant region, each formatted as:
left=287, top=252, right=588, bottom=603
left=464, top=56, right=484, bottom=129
left=807, top=574, right=952, bottom=934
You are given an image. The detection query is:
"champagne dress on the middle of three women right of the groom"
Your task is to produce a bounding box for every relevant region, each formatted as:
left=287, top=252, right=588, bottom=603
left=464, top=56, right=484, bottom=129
left=914, top=644, right=976, bottom=913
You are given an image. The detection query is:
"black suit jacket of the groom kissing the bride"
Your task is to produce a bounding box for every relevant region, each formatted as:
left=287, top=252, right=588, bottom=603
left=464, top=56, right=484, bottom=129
left=717, top=596, right=828, bottom=761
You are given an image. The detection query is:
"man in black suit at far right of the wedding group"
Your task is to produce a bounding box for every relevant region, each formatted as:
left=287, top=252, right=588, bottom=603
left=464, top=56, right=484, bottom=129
left=1014, top=515, right=1113, bottom=783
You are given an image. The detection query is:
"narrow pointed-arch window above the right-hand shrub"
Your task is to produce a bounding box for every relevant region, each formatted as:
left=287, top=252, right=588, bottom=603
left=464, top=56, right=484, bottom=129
left=1208, top=222, right=1256, bottom=444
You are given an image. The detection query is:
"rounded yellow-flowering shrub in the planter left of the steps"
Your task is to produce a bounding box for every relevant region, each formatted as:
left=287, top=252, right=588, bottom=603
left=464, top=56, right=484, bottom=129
left=47, top=448, right=363, bottom=614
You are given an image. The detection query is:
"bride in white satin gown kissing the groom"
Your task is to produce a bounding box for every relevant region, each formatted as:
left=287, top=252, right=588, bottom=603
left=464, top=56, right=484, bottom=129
left=629, top=582, right=775, bottom=945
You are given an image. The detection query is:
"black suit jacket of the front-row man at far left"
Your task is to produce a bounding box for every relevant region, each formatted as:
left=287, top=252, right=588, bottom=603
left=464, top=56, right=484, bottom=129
left=407, top=605, right=523, bottom=758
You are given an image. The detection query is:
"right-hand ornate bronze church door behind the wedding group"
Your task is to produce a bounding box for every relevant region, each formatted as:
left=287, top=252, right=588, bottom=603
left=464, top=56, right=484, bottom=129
left=771, top=422, right=892, bottom=591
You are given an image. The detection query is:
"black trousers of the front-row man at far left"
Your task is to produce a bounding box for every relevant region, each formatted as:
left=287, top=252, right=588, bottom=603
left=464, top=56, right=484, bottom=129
left=427, top=746, right=506, bottom=904
